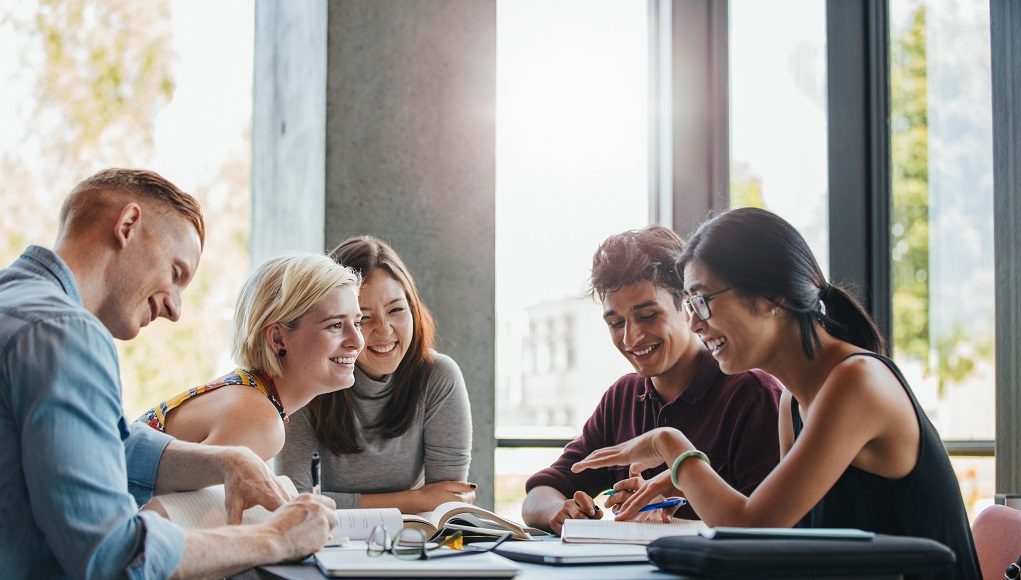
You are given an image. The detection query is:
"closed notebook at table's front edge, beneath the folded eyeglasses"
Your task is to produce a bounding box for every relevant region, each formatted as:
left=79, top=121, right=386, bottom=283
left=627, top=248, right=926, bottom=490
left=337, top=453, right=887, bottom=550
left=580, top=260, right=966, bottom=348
left=315, top=548, right=521, bottom=578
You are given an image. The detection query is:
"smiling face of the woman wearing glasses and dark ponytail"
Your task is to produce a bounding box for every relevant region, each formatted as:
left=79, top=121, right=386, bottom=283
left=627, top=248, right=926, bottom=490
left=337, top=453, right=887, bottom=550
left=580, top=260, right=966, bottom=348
left=684, top=260, right=783, bottom=375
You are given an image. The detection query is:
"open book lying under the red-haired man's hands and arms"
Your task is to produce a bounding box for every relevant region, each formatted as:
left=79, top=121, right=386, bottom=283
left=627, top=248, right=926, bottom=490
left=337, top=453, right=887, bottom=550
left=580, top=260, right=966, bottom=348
left=153, top=476, right=403, bottom=541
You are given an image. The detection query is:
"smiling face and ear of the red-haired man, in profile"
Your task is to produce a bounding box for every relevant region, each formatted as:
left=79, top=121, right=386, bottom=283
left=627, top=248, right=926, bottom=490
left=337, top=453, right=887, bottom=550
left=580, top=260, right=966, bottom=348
left=95, top=209, right=202, bottom=340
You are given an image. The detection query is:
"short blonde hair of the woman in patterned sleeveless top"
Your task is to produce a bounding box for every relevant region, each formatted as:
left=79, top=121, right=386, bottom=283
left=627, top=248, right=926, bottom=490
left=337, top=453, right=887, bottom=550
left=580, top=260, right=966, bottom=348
left=232, top=253, right=361, bottom=377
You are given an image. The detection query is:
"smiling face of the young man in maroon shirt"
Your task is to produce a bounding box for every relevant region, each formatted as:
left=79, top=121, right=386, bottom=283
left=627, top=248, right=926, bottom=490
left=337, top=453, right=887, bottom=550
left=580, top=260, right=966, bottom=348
left=602, top=282, right=698, bottom=382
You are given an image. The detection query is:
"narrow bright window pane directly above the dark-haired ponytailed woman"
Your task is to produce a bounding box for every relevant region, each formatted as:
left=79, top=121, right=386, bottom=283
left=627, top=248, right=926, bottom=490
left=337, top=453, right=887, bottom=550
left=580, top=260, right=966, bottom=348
left=730, top=0, right=829, bottom=273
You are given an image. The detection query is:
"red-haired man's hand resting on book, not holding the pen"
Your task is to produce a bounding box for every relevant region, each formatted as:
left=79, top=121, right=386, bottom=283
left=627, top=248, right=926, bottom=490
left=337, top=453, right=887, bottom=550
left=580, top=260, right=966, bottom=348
left=218, top=447, right=291, bottom=525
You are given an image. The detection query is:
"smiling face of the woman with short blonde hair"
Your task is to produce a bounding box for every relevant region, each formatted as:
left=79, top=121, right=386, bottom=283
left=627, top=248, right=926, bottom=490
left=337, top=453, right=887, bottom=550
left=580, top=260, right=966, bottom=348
left=270, top=286, right=364, bottom=394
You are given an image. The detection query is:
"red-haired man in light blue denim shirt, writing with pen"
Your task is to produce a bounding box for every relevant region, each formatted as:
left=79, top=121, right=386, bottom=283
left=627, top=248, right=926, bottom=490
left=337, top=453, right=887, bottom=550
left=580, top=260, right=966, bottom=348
left=0, top=170, right=337, bottom=578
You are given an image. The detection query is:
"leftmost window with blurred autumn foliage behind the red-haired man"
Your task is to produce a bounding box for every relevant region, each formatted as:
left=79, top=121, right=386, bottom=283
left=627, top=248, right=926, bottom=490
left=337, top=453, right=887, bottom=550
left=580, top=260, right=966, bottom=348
left=0, top=0, right=254, bottom=419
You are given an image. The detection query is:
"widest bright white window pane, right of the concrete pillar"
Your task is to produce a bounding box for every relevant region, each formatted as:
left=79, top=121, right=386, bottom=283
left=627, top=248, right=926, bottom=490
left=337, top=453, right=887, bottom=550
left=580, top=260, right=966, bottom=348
left=496, top=0, right=648, bottom=517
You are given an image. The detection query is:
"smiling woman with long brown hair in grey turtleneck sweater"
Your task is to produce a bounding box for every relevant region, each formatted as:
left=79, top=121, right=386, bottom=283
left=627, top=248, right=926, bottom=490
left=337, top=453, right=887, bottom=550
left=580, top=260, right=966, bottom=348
left=276, top=236, right=475, bottom=513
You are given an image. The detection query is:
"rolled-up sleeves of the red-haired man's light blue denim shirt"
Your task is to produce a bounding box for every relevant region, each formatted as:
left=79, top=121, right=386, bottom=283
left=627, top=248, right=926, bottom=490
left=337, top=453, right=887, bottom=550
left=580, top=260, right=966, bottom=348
left=7, top=316, right=184, bottom=578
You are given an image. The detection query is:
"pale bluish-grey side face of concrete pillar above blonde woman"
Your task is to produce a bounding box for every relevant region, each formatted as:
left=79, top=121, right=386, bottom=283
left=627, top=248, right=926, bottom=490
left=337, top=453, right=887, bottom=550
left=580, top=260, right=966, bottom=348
left=249, top=0, right=327, bottom=265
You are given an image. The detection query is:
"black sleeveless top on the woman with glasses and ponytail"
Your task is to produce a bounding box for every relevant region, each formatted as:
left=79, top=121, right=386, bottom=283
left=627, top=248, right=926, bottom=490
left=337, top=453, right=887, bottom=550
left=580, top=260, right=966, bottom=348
left=790, top=352, right=979, bottom=579
